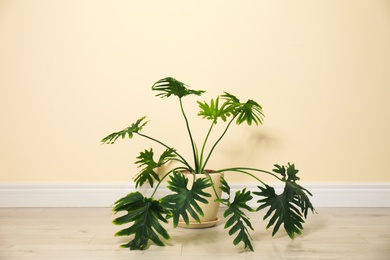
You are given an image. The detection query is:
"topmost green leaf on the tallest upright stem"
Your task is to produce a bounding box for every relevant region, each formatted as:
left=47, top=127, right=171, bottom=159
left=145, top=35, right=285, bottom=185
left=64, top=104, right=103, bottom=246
left=152, top=77, right=205, bottom=98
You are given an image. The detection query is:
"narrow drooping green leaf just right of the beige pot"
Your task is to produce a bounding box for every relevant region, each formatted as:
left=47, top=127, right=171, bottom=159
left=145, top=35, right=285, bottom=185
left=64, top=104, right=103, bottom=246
left=219, top=178, right=254, bottom=251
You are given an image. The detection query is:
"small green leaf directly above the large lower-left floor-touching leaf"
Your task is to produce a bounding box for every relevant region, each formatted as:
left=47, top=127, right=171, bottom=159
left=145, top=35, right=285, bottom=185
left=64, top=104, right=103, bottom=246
left=134, top=148, right=176, bottom=187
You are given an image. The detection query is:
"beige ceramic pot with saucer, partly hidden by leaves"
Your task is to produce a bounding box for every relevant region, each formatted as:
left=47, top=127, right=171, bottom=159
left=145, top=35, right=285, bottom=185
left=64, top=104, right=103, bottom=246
left=179, top=171, right=223, bottom=228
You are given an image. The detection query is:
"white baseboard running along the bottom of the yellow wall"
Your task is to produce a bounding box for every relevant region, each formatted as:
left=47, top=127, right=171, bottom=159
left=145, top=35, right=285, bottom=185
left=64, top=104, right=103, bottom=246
left=0, top=183, right=390, bottom=208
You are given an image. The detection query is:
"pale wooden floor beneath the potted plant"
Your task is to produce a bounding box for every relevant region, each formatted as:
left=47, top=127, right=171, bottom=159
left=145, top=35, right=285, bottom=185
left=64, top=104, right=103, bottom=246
left=0, top=208, right=390, bottom=260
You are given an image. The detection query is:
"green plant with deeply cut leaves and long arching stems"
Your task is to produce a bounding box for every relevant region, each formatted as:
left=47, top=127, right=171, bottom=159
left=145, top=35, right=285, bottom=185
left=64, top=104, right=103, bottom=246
left=101, top=77, right=314, bottom=251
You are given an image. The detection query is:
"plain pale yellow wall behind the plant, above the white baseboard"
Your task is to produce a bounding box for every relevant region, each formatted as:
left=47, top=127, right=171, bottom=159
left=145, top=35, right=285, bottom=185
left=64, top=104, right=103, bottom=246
left=0, top=0, right=390, bottom=183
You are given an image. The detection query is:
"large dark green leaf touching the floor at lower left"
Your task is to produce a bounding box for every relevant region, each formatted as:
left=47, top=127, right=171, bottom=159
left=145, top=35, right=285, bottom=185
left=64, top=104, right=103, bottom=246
left=113, top=192, right=170, bottom=250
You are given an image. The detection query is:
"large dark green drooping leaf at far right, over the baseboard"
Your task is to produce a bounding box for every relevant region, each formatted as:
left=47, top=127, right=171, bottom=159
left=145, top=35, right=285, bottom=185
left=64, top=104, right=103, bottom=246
left=254, top=164, right=314, bottom=238
